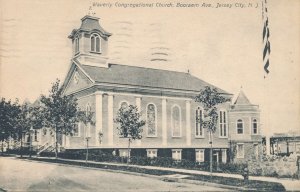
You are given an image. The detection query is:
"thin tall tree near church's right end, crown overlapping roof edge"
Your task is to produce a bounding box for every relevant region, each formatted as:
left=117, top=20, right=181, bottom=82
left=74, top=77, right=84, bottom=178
left=195, top=86, right=231, bottom=173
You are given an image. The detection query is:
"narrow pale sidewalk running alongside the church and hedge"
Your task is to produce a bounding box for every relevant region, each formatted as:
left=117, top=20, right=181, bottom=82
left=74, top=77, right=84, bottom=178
left=35, top=157, right=300, bottom=191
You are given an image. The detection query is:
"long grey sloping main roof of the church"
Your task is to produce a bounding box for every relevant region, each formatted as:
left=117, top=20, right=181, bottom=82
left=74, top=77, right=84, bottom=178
left=77, top=62, right=231, bottom=95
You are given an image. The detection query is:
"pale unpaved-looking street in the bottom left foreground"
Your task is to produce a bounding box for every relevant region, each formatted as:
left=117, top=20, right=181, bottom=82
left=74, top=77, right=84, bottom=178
left=0, top=157, right=225, bottom=192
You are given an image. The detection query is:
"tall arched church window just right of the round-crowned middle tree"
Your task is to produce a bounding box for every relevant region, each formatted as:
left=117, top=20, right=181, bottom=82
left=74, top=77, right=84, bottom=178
left=147, top=104, right=157, bottom=137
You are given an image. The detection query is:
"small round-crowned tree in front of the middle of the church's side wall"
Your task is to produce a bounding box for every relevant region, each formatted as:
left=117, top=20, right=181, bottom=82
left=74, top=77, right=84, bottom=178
left=115, top=105, right=145, bottom=163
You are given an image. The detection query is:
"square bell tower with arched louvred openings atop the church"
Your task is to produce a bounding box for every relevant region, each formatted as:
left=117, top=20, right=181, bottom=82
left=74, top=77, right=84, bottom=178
left=68, top=15, right=112, bottom=67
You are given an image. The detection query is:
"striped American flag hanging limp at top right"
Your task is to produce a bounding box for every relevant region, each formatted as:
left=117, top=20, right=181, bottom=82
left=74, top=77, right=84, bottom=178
left=262, top=0, right=271, bottom=77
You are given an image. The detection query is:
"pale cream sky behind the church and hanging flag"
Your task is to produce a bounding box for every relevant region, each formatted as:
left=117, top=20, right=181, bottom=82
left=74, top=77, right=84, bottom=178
left=0, top=0, right=300, bottom=134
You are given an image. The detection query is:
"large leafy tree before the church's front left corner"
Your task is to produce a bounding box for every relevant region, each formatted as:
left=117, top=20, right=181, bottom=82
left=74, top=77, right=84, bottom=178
left=41, top=79, right=79, bottom=158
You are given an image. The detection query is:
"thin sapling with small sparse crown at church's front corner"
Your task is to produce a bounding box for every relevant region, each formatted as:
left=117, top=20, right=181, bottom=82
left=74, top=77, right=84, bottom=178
left=78, top=109, right=95, bottom=162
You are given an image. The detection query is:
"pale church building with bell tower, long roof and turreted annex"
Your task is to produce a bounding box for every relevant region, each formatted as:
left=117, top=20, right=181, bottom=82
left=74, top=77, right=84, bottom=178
left=40, top=16, right=261, bottom=163
